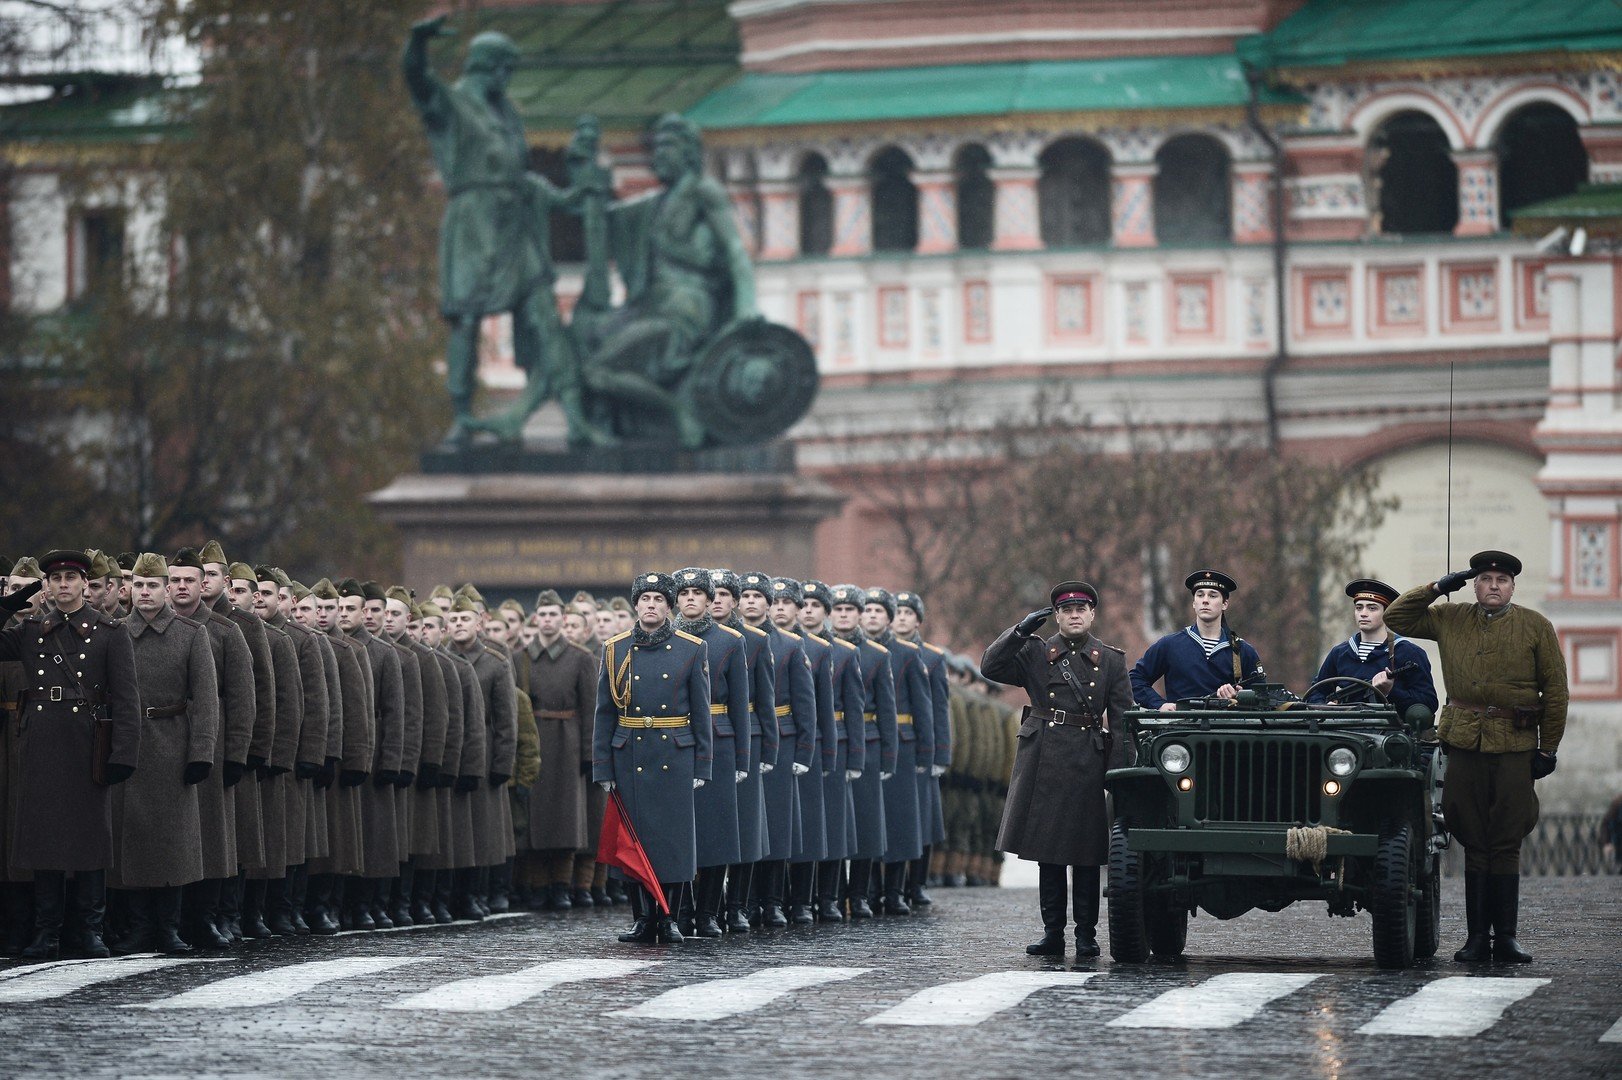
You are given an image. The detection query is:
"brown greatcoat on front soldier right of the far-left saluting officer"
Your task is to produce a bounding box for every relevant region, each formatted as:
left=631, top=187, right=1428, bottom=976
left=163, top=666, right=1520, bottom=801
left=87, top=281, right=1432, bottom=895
left=107, top=605, right=219, bottom=889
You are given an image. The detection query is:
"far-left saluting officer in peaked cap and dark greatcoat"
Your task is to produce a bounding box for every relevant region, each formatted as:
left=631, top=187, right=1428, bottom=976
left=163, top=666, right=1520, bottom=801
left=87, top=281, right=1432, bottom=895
left=0, top=550, right=141, bottom=960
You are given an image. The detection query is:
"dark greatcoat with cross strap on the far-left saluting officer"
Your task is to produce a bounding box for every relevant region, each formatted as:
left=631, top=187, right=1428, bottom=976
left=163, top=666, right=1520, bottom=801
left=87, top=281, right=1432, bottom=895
left=0, top=605, right=141, bottom=871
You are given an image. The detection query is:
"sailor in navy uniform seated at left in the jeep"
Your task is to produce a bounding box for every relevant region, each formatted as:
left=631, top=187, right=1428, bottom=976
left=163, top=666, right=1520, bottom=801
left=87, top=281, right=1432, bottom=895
left=1128, top=569, right=1267, bottom=712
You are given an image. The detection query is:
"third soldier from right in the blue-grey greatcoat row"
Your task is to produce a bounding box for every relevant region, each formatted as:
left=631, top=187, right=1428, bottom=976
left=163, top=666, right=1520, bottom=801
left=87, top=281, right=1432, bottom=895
left=829, top=585, right=899, bottom=919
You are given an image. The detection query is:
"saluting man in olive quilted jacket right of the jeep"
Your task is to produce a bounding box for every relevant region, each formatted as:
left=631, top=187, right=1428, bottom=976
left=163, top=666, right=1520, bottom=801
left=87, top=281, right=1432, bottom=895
left=1385, top=551, right=1570, bottom=963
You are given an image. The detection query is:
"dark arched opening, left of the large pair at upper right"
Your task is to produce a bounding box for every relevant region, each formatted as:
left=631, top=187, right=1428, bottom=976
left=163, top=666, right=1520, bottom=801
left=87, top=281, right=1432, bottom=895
left=1369, top=112, right=1458, bottom=235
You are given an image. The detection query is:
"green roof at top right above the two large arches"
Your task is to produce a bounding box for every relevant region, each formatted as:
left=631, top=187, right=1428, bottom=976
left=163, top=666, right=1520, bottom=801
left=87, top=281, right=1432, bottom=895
left=1238, top=0, right=1622, bottom=68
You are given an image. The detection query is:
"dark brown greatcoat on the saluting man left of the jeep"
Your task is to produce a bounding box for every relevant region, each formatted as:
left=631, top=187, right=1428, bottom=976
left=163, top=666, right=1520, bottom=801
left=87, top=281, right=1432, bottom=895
left=980, top=629, right=1134, bottom=866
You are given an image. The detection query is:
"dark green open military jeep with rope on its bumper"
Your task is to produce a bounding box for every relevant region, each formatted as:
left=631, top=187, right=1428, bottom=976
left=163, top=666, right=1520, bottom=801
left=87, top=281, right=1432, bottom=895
left=1105, top=679, right=1448, bottom=968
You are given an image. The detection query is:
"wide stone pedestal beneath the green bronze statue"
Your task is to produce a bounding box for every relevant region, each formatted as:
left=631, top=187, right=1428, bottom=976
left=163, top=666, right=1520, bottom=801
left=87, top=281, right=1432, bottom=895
left=370, top=446, right=845, bottom=606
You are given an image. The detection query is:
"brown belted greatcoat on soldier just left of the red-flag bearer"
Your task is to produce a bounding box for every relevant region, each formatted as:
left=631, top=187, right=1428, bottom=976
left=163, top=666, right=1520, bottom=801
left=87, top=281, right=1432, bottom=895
left=519, top=637, right=597, bottom=851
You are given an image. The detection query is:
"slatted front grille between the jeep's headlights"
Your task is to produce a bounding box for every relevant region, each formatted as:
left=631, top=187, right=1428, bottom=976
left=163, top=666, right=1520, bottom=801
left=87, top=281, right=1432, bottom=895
left=1192, top=738, right=1322, bottom=825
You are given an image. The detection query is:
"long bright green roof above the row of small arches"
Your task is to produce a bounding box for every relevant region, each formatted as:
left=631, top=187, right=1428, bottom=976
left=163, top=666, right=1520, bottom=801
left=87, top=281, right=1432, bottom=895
left=688, top=55, right=1299, bottom=130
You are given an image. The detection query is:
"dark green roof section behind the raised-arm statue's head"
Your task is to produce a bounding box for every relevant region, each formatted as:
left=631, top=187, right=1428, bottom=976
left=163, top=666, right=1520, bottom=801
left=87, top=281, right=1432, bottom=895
left=436, top=0, right=738, bottom=131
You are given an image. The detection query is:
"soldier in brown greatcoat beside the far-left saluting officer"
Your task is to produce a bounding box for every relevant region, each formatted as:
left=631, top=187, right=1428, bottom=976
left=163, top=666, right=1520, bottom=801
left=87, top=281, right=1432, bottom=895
left=114, top=553, right=219, bottom=955
